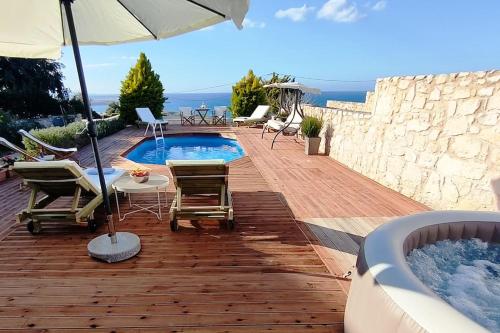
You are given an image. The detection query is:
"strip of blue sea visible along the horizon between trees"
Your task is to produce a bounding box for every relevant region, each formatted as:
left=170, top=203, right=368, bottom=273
left=90, top=91, right=366, bottom=114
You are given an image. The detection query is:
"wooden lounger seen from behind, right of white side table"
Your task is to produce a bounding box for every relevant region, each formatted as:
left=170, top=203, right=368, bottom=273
left=167, top=160, right=234, bottom=231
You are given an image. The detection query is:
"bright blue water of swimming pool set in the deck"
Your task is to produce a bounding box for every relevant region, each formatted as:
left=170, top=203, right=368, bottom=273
left=126, top=135, right=245, bottom=165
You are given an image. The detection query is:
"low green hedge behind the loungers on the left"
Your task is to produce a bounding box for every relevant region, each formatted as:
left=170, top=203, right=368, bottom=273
left=23, top=118, right=125, bottom=155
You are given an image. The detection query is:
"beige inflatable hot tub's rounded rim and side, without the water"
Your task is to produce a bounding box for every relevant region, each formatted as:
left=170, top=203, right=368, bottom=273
left=344, top=211, right=500, bottom=333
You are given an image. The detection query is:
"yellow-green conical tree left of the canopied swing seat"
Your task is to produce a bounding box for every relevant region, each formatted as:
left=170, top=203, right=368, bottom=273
left=231, top=70, right=266, bottom=117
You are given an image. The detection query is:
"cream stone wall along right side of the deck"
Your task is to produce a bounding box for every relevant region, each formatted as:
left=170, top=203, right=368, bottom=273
left=305, top=71, right=500, bottom=210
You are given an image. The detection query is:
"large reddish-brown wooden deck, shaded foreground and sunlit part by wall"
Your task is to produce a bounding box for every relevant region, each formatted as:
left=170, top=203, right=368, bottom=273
left=0, top=128, right=425, bottom=332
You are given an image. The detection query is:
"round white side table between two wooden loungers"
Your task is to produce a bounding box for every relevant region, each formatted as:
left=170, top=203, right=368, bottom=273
left=113, top=175, right=170, bottom=221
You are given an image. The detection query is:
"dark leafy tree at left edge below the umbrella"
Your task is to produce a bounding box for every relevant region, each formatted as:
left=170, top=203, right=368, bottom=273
left=0, top=57, right=68, bottom=118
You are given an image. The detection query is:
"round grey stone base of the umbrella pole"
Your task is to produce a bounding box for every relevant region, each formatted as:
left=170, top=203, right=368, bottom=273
left=87, top=232, right=141, bottom=263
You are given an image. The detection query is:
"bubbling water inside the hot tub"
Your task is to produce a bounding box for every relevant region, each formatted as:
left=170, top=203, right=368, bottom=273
left=406, top=239, right=500, bottom=332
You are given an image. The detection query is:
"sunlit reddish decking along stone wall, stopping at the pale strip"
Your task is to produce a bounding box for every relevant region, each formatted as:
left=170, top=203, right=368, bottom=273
left=236, top=128, right=428, bottom=219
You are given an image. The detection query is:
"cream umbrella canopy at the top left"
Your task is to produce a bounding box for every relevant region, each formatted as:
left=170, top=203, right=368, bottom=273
left=0, top=0, right=249, bottom=59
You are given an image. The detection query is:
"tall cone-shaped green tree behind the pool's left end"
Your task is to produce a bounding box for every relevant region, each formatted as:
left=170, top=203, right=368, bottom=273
left=120, top=52, right=166, bottom=124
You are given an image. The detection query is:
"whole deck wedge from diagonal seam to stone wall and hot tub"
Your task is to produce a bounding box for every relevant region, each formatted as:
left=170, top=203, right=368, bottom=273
left=236, top=128, right=429, bottom=280
